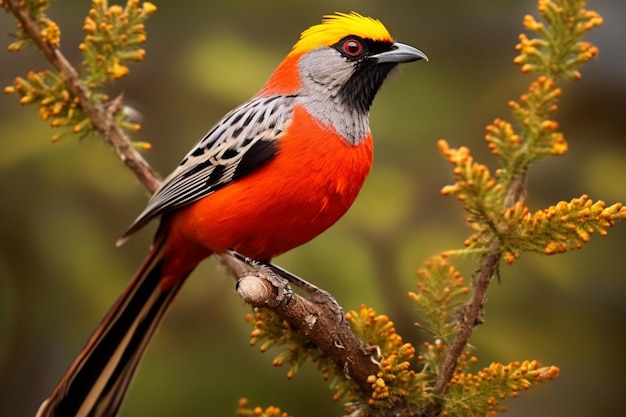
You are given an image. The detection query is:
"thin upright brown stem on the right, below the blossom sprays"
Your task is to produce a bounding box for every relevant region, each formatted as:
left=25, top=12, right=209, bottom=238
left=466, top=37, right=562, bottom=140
left=426, top=175, right=526, bottom=416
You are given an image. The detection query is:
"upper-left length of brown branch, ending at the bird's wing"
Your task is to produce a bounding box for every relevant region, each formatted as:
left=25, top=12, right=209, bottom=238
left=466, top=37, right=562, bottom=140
left=4, top=0, right=160, bottom=193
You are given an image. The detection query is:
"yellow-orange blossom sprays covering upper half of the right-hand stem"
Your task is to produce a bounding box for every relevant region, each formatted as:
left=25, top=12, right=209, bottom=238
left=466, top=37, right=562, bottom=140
left=439, top=0, right=625, bottom=263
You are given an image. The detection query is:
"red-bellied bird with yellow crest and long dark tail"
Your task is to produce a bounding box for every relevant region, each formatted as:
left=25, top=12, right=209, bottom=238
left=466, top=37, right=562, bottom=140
left=36, top=12, right=428, bottom=417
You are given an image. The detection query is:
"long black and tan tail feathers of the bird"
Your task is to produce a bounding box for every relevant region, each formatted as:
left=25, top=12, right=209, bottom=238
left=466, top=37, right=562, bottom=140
left=36, top=233, right=191, bottom=417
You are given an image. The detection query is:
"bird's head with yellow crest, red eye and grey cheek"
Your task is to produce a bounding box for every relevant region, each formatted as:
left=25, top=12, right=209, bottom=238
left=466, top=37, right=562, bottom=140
left=263, top=12, right=428, bottom=114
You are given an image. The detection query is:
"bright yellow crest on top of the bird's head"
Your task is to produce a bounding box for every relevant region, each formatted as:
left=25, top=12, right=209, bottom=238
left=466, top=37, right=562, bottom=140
left=290, top=12, right=392, bottom=55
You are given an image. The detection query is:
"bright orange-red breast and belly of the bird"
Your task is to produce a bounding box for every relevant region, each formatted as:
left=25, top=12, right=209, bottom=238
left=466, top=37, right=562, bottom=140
left=169, top=106, right=372, bottom=260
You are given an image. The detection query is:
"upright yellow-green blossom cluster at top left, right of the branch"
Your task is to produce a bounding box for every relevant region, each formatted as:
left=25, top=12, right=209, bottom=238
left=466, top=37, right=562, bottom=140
left=78, top=0, right=156, bottom=84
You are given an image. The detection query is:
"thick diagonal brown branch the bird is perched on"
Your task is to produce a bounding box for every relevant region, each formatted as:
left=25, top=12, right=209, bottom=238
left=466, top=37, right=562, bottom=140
left=3, top=0, right=378, bottom=393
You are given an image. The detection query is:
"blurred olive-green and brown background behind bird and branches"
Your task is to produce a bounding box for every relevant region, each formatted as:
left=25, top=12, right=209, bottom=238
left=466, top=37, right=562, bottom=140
left=0, top=0, right=626, bottom=417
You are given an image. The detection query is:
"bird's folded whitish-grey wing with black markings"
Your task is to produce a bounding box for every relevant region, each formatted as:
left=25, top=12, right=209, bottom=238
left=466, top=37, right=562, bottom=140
left=118, top=95, right=295, bottom=240
